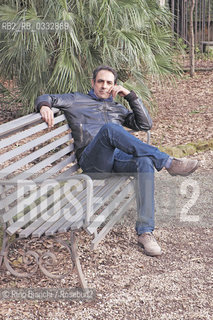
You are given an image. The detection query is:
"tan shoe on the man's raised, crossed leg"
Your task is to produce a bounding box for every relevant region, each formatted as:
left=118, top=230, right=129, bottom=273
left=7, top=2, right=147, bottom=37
left=166, top=158, right=199, bottom=177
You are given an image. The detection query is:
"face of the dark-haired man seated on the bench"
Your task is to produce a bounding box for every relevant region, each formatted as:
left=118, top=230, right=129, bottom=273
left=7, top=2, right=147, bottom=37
left=92, top=70, right=115, bottom=99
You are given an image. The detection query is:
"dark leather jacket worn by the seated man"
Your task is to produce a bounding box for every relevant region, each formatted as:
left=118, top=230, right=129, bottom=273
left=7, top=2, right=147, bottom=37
left=35, top=91, right=152, bottom=160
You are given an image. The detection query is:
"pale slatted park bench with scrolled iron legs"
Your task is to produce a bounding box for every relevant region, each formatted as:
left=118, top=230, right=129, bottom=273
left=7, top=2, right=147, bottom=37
left=0, top=109, right=146, bottom=288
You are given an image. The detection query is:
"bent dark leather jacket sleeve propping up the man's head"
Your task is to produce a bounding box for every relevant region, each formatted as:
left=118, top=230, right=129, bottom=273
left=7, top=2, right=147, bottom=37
left=124, top=91, right=152, bottom=131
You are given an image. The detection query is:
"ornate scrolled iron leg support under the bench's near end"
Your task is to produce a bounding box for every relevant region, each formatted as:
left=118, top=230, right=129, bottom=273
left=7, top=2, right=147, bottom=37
left=0, top=231, right=87, bottom=289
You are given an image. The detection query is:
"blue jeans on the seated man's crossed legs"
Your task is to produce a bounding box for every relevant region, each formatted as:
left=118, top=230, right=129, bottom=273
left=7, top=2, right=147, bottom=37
left=79, top=123, right=169, bottom=235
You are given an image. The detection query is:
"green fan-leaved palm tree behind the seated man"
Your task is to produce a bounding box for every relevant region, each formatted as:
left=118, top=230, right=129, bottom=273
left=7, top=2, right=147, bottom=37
left=0, top=0, right=179, bottom=112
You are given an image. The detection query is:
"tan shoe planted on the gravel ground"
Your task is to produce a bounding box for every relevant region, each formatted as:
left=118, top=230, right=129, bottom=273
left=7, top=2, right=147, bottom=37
left=138, top=232, right=162, bottom=257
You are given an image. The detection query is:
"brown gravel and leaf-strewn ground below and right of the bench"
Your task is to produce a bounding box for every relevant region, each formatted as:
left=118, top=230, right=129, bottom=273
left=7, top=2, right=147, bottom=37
left=0, top=63, right=213, bottom=320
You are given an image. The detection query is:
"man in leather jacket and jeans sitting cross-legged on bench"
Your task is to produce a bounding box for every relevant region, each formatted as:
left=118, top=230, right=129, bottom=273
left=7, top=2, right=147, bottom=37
left=35, top=66, right=198, bottom=256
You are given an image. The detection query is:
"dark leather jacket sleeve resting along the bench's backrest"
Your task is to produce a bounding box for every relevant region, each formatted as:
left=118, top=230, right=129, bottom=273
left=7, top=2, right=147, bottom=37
left=35, top=93, right=75, bottom=112
